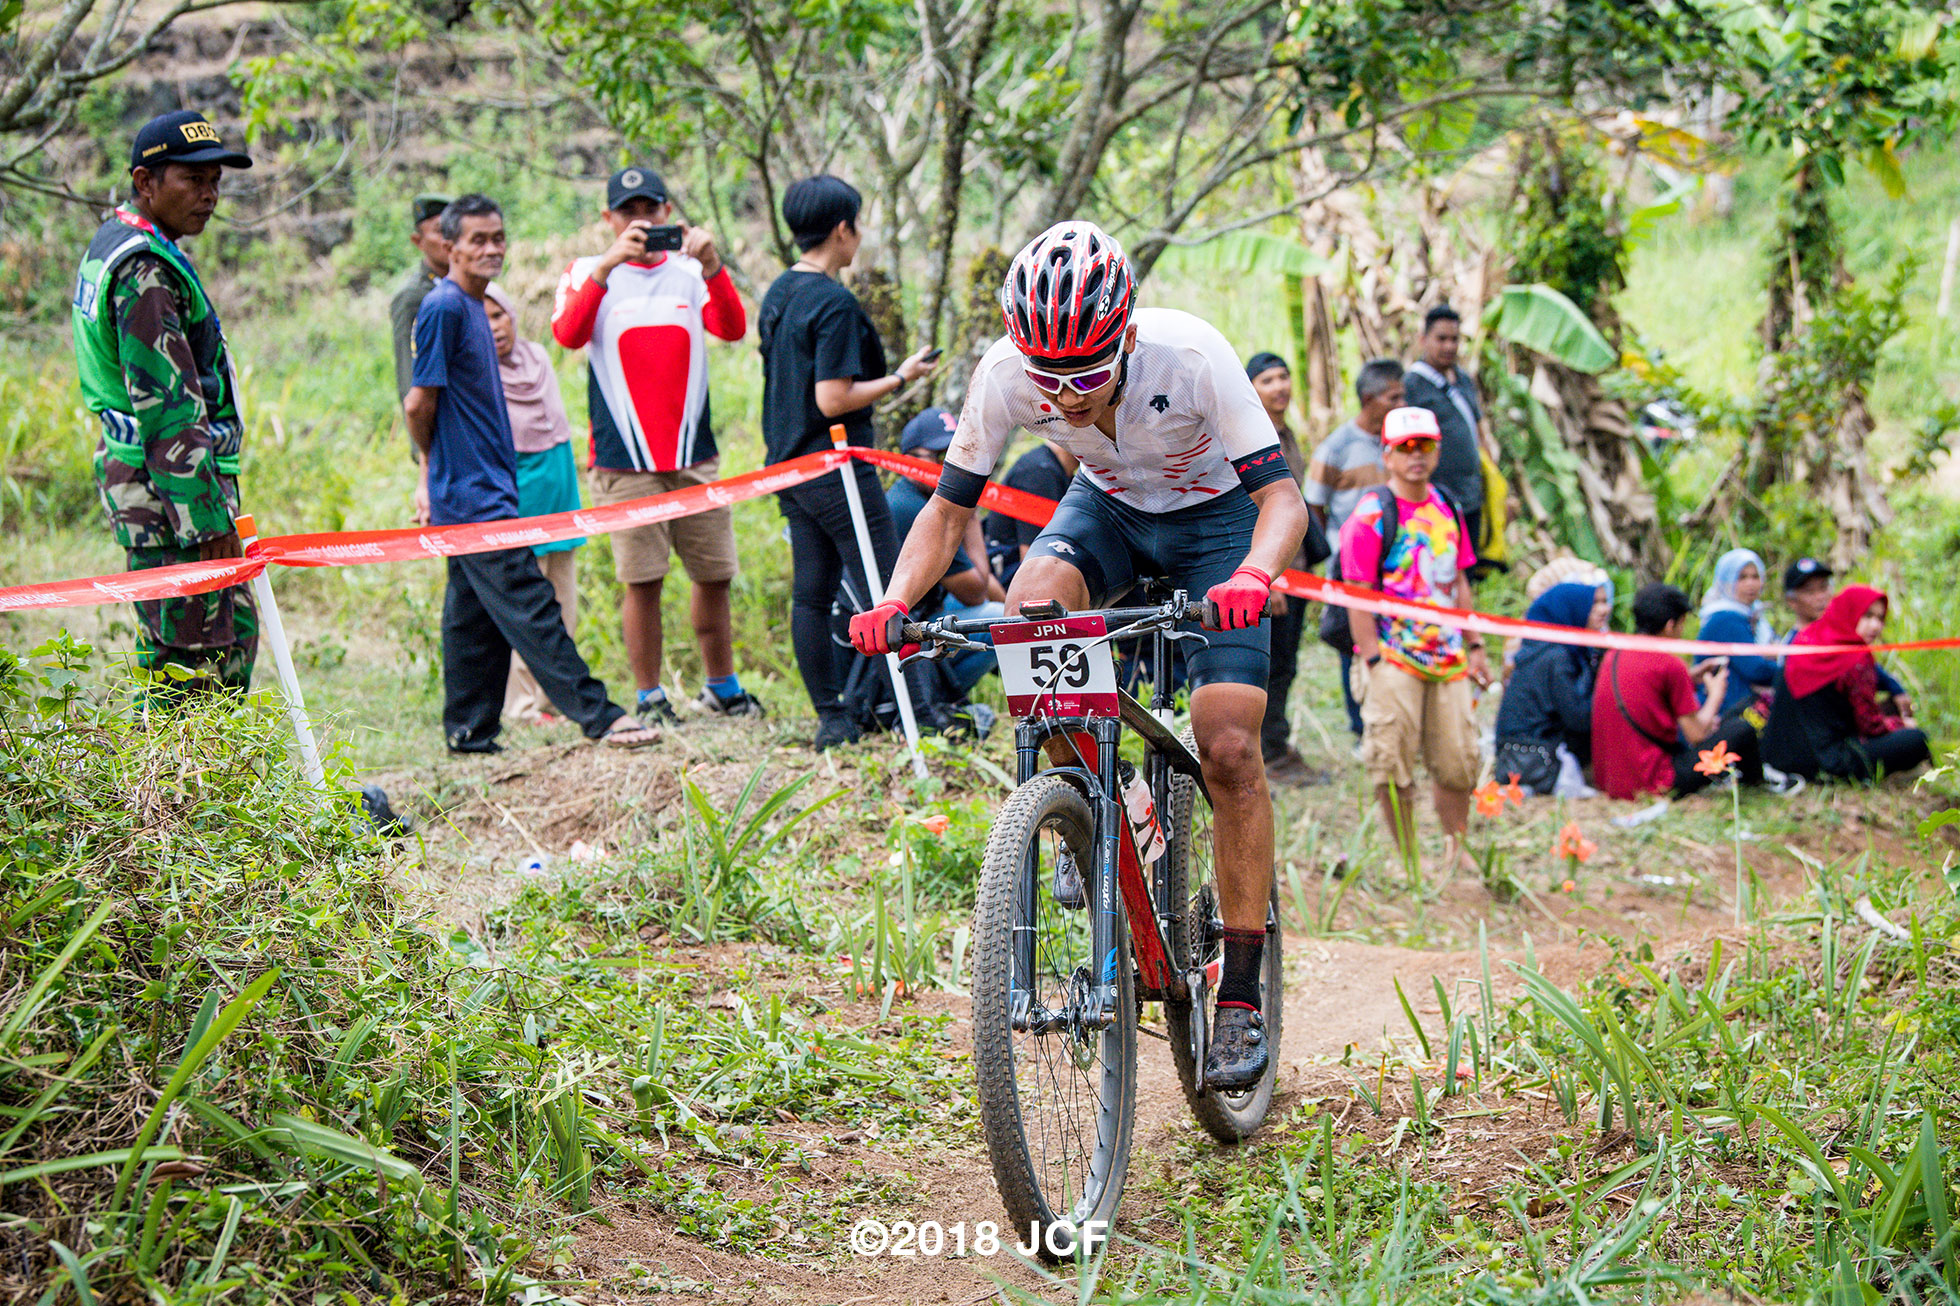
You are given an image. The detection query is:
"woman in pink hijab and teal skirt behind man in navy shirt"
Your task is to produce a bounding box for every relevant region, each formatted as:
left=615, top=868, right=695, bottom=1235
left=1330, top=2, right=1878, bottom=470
left=484, top=280, right=584, bottom=724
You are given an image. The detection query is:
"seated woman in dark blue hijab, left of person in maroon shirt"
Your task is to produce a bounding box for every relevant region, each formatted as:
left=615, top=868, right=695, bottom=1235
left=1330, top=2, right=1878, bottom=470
left=1495, top=580, right=1611, bottom=798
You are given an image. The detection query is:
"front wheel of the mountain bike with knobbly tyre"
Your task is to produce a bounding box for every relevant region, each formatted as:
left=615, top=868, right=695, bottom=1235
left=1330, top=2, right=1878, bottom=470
left=972, top=777, right=1137, bottom=1261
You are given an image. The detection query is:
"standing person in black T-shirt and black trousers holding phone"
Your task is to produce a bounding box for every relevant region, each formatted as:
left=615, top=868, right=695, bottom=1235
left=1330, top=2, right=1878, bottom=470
left=757, top=176, right=945, bottom=751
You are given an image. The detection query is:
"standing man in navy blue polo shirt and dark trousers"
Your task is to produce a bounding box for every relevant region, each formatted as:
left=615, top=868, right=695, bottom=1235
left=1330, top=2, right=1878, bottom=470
left=402, top=194, right=659, bottom=753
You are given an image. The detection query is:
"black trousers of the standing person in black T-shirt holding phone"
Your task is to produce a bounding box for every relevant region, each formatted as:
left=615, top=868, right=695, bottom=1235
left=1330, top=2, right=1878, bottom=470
left=776, top=463, right=939, bottom=716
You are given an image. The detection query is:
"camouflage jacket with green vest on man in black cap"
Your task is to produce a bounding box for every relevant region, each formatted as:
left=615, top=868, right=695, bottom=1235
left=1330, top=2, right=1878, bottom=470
left=73, top=208, right=243, bottom=549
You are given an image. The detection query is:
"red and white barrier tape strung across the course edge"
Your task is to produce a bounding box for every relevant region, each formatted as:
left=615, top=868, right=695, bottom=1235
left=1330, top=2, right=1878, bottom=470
left=0, top=447, right=1960, bottom=657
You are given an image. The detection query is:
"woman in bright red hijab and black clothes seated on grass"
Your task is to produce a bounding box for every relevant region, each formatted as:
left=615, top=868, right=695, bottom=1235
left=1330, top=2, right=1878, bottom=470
left=1762, top=584, right=1933, bottom=780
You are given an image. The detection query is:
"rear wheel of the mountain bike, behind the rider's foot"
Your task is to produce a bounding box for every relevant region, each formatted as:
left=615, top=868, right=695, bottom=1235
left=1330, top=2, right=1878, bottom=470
left=1164, top=731, right=1286, bottom=1143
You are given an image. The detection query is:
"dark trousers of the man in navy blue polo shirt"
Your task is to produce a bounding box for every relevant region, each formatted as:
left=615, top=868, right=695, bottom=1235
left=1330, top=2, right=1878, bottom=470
left=443, top=549, right=625, bottom=753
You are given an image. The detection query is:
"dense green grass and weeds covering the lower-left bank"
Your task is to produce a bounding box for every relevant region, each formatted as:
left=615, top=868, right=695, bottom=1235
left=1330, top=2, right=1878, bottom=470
left=0, top=639, right=962, bottom=1302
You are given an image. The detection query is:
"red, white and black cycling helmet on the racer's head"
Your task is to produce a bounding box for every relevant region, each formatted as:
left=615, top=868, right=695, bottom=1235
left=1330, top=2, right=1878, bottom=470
left=1000, top=220, right=1137, bottom=361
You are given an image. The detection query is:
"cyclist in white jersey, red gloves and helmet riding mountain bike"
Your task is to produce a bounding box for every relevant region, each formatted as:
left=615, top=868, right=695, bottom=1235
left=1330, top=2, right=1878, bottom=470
left=851, top=222, right=1307, bottom=1090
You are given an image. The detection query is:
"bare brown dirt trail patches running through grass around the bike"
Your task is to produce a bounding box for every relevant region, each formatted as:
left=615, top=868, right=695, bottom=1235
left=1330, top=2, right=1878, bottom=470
left=394, top=731, right=1944, bottom=1306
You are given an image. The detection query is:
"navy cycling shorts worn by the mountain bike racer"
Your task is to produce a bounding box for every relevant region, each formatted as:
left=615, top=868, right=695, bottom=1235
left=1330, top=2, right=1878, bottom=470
left=1027, top=477, right=1272, bottom=688
